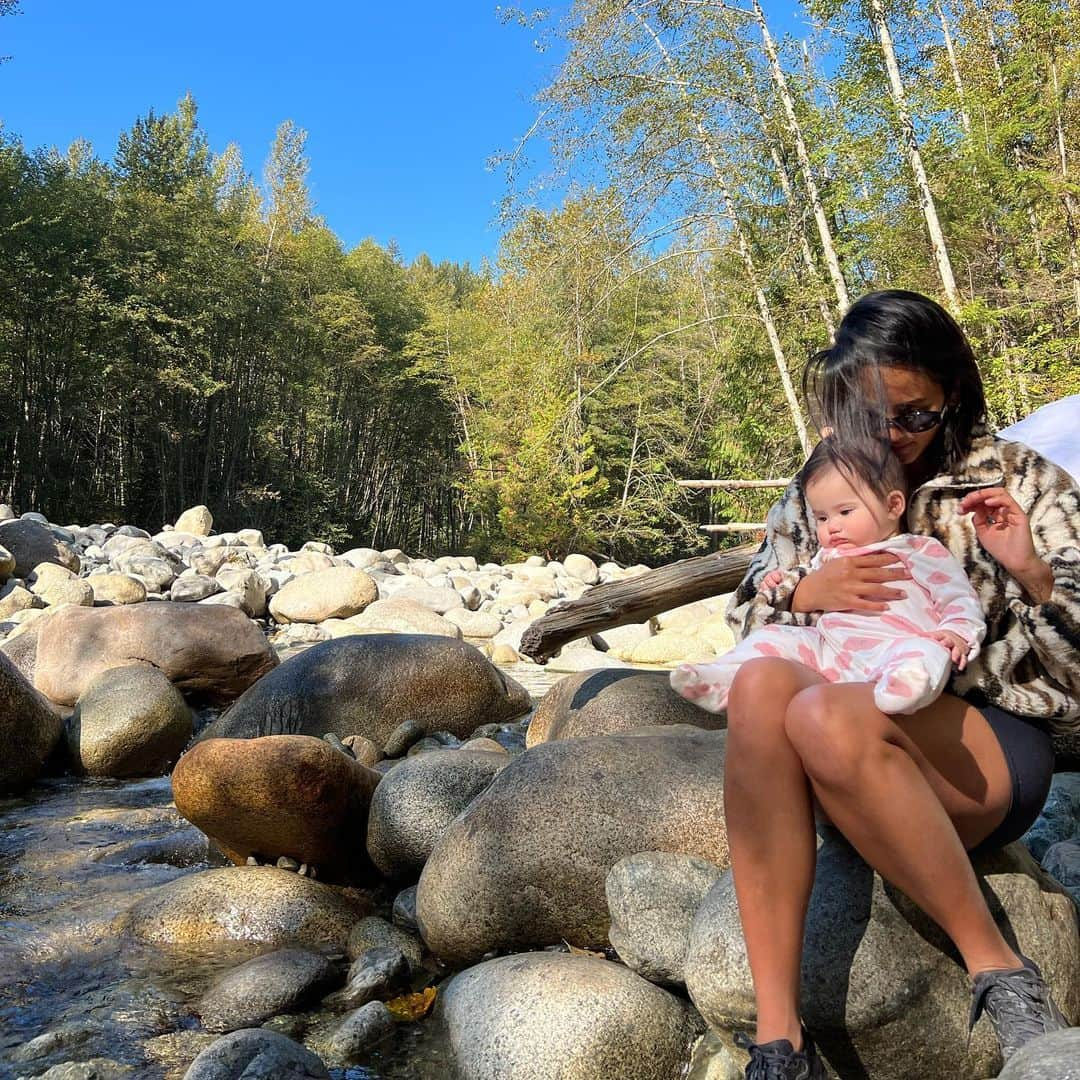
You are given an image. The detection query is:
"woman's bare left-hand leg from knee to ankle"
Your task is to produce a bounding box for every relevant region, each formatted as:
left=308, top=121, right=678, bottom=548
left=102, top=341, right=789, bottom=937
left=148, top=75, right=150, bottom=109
left=724, top=659, right=824, bottom=1048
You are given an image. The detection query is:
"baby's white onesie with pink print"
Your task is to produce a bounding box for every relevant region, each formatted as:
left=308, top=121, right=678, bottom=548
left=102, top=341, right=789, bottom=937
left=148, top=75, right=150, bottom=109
left=671, top=532, right=986, bottom=714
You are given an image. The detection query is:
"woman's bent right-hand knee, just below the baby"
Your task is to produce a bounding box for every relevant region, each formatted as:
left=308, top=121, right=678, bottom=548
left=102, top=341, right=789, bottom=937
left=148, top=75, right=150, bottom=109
left=784, top=684, right=885, bottom=784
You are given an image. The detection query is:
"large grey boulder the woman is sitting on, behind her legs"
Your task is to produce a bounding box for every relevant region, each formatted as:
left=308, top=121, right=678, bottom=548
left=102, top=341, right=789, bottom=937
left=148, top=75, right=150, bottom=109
left=686, top=829, right=1080, bottom=1080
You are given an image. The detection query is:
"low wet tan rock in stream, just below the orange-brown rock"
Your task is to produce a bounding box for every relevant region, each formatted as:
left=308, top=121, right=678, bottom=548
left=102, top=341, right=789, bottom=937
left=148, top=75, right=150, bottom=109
left=119, top=866, right=368, bottom=953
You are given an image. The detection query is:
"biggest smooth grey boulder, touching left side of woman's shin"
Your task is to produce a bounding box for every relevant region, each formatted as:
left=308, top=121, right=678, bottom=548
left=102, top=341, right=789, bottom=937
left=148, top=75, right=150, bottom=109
left=417, top=727, right=728, bottom=963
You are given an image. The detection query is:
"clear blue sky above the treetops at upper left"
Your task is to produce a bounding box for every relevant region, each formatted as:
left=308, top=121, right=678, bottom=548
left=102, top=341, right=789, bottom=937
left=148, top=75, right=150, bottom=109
left=0, top=0, right=553, bottom=265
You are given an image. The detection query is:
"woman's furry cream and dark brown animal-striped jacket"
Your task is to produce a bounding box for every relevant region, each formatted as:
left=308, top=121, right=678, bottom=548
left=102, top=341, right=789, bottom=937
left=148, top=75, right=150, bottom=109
left=727, top=429, right=1080, bottom=735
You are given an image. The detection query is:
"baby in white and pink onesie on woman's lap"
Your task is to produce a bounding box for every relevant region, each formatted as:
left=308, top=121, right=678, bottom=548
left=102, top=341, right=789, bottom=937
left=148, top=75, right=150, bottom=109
left=671, top=438, right=986, bottom=714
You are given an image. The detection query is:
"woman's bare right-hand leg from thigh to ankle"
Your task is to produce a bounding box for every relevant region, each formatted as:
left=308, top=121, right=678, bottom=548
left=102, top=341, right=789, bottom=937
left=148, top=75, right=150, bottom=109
left=785, top=684, right=1021, bottom=975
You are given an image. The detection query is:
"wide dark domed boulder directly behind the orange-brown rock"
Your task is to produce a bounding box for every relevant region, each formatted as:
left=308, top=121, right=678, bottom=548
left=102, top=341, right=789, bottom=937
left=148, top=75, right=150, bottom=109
left=206, top=634, right=530, bottom=746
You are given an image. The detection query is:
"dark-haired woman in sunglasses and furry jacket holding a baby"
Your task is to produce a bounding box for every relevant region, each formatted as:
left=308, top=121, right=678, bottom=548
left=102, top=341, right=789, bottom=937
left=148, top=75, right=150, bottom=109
left=725, top=291, right=1080, bottom=1080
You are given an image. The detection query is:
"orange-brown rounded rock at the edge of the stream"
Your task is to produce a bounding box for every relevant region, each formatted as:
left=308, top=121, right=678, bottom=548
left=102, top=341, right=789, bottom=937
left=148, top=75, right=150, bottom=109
left=173, top=735, right=381, bottom=881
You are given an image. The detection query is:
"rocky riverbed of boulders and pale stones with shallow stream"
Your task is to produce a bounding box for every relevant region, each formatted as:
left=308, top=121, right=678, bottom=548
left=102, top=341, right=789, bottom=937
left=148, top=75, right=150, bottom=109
left=0, top=508, right=1080, bottom=1080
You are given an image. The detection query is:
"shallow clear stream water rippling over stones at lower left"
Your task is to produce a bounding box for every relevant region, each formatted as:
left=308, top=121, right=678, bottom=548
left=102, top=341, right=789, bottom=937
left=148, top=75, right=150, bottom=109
left=0, top=664, right=565, bottom=1080
